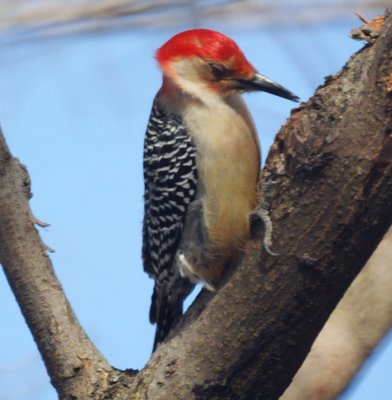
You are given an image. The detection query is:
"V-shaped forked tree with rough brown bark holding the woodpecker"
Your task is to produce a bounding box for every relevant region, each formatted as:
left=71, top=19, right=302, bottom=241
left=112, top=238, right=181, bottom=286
left=0, top=8, right=392, bottom=400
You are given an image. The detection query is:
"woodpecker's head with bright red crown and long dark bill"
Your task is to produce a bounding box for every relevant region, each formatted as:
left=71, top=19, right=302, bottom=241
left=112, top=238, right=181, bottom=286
left=156, top=29, right=298, bottom=101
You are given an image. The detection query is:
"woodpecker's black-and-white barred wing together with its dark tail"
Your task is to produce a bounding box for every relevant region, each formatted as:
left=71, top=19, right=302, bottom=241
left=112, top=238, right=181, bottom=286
left=142, top=100, right=197, bottom=350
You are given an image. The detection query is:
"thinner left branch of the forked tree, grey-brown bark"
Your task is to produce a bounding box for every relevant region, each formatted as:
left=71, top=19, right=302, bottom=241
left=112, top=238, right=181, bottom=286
left=0, top=135, right=115, bottom=399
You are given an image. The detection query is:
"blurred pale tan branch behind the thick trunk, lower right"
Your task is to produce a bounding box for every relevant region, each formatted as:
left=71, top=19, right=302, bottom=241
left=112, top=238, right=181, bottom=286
left=280, top=229, right=392, bottom=400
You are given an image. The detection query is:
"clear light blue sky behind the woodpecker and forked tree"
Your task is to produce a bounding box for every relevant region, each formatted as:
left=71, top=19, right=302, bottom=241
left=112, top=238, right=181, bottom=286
left=0, top=18, right=392, bottom=400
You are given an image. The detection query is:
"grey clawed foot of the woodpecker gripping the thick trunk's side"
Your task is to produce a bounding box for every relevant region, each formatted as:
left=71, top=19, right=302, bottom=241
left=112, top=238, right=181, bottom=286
left=251, top=173, right=286, bottom=256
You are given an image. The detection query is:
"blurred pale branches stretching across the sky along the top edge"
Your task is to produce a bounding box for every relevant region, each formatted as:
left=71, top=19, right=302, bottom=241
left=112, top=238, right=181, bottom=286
left=0, top=0, right=388, bottom=43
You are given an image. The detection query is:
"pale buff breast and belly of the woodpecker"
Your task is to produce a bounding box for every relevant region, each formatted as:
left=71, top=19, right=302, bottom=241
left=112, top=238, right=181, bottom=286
left=185, top=94, right=260, bottom=258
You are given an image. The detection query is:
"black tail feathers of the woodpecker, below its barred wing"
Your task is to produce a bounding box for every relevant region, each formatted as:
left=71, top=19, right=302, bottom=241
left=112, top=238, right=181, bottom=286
left=150, top=277, right=194, bottom=352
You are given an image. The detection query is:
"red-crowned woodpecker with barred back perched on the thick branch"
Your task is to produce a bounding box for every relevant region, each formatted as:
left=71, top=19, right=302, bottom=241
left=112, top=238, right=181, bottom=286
left=142, top=29, right=298, bottom=351
